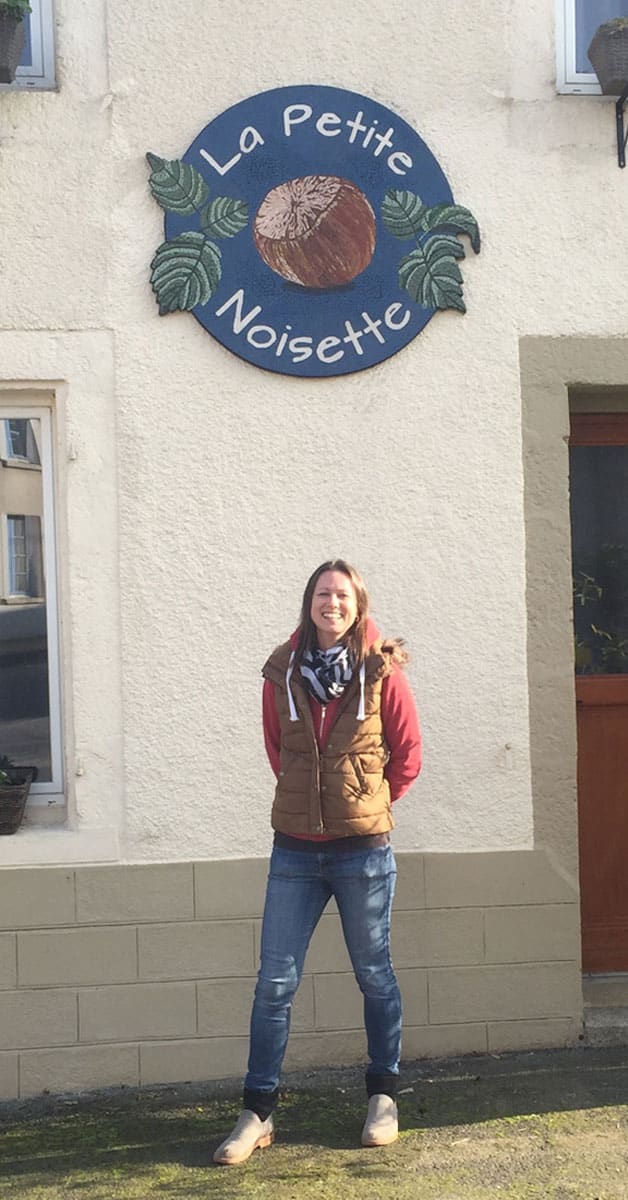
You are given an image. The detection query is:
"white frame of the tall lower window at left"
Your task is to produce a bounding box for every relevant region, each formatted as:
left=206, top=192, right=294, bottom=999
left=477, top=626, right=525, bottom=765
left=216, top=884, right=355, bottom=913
left=0, top=403, right=64, bottom=808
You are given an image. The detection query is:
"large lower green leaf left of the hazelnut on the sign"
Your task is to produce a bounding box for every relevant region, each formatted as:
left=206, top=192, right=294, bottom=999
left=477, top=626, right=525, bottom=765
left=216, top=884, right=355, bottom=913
left=150, top=230, right=222, bottom=314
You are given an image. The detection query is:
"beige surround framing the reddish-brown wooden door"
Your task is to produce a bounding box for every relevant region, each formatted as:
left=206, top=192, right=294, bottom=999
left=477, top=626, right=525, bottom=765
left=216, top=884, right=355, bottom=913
left=519, top=336, right=628, bottom=984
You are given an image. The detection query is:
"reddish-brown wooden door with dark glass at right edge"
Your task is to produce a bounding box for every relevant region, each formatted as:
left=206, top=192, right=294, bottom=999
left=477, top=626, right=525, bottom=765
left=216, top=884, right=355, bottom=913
left=569, top=413, right=628, bottom=972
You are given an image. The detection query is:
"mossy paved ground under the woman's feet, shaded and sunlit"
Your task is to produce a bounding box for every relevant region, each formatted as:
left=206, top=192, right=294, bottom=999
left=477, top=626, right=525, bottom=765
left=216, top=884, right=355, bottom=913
left=0, top=1048, right=628, bottom=1200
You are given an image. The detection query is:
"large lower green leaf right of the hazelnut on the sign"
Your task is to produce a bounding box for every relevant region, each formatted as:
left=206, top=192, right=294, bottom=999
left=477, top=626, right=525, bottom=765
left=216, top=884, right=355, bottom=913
left=399, top=235, right=466, bottom=312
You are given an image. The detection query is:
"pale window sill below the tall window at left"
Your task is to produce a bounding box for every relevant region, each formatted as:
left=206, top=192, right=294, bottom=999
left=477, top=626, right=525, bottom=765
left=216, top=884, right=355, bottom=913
left=0, top=826, right=120, bottom=866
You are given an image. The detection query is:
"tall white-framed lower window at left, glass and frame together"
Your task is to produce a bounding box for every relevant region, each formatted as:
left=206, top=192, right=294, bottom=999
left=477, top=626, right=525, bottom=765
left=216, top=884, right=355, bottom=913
left=0, top=408, right=62, bottom=803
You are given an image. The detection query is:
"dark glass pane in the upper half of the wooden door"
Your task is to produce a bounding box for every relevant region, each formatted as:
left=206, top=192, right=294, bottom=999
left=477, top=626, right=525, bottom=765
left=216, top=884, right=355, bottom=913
left=569, top=446, right=628, bottom=674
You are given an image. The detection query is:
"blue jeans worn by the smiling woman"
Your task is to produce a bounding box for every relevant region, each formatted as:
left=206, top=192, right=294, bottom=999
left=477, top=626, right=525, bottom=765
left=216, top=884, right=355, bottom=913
left=245, top=845, right=401, bottom=1108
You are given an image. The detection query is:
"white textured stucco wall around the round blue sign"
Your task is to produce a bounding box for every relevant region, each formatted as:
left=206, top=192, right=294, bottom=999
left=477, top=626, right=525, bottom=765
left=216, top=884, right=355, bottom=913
left=0, top=0, right=628, bottom=862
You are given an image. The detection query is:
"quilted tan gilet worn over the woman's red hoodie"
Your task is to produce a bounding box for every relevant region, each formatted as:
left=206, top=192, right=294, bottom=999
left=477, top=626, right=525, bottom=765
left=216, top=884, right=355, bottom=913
left=262, top=641, right=394, bottom=838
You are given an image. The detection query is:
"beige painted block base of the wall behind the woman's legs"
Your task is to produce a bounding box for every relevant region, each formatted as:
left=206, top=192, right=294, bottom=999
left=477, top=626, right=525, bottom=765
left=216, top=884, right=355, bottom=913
left=0, top=851, right=582, bottom=1099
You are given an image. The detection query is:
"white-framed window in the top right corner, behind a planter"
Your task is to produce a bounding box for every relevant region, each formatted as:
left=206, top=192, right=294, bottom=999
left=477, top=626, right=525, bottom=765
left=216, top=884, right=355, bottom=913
left=556, top=0, right=628, bottom=95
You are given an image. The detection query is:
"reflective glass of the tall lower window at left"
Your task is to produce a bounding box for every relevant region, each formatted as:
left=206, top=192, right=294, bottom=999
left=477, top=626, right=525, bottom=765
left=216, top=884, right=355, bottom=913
left=0, top=418, right=52, bottom=782
